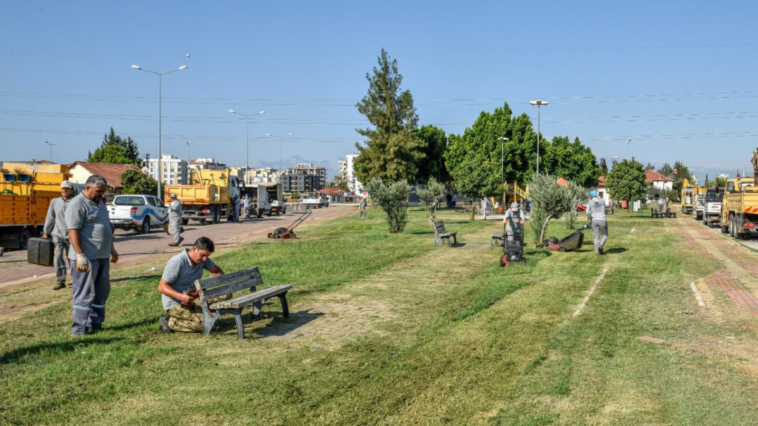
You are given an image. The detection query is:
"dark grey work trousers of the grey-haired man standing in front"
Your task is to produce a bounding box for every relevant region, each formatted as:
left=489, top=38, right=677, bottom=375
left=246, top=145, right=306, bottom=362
left=71, top=259, right=111, bottom=334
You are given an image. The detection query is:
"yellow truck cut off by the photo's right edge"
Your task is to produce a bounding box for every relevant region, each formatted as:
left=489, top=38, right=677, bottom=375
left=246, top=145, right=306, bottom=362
left=720, top=161, right=758, bottom=239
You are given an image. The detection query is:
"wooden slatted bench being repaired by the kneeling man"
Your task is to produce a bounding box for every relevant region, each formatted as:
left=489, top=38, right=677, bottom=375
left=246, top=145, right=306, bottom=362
left=195, top=266, right=292, bottom=339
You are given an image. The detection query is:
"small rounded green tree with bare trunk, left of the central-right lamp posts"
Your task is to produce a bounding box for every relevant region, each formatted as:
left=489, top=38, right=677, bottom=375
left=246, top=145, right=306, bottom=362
left=450, top=154, right=503, bottom=220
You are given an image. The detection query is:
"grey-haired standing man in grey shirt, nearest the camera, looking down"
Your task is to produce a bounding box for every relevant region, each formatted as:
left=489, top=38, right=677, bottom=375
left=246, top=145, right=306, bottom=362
left=66, top=175, right=118, bottom=336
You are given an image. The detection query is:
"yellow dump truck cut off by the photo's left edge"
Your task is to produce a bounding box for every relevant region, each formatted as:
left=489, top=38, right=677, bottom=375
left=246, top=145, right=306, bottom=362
left=0, top=163, right=68, bottom=256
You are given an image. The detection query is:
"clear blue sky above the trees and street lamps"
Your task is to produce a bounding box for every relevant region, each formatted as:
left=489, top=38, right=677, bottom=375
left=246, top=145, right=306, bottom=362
left=0, top=1, right=758, bottom=178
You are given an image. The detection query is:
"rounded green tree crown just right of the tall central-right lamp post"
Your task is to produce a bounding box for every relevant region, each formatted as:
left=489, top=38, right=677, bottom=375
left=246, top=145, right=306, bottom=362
left=540, top=136, right=602, bottom=187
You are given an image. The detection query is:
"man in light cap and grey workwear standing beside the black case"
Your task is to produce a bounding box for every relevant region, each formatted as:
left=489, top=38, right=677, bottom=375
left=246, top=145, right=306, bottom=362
left=42, top=180, right=74, bottom=290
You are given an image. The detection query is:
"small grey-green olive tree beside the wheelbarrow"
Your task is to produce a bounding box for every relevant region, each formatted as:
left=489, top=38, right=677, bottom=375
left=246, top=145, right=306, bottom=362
left=529, top=175, right=584, bottom=246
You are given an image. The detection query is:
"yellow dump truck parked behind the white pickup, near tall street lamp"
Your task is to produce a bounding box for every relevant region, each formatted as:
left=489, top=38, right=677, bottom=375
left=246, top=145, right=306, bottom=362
left=163, top=169, right=242, bottom=225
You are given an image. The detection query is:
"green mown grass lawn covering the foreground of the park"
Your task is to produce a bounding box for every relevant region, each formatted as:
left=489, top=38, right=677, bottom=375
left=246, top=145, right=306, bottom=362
left=0, top=210, right=758, bottom=425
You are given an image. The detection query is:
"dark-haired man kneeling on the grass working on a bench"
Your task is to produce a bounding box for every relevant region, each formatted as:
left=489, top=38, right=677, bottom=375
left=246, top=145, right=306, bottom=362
left=158, top=237, right=232, bottom=333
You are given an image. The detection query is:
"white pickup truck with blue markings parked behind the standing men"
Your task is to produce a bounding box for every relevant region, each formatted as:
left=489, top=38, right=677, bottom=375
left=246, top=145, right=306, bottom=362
left=108, top=195, right=168, bottom=234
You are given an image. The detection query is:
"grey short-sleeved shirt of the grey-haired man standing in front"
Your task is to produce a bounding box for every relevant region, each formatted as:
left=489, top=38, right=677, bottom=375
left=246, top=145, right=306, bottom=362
left=66, top=194, right=113, bottom=260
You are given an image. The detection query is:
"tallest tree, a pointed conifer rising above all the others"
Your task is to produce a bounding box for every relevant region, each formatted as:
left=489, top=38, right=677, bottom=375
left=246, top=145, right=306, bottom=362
left=355, top=49, right=426, bottom=182
